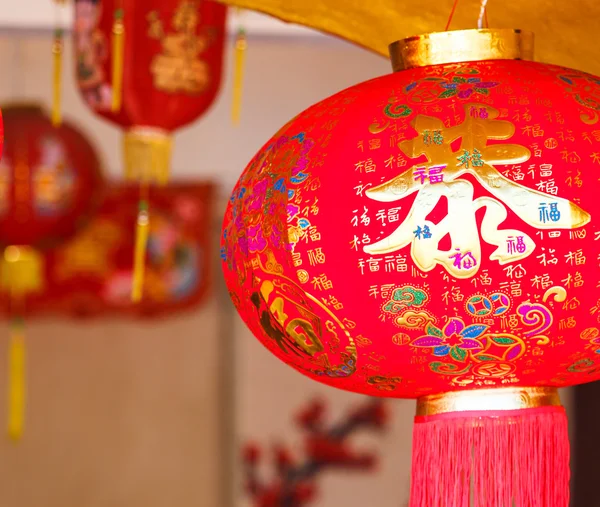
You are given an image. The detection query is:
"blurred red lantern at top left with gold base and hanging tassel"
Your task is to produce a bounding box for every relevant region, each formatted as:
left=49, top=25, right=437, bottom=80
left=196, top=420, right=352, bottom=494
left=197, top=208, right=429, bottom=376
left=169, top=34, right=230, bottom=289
left=74, top=0, right=226, bottom=301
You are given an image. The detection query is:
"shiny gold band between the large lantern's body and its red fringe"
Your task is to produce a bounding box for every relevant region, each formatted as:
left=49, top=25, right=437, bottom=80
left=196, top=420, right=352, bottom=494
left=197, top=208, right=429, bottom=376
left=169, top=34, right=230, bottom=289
left=417, top=387, right=561, bottom=417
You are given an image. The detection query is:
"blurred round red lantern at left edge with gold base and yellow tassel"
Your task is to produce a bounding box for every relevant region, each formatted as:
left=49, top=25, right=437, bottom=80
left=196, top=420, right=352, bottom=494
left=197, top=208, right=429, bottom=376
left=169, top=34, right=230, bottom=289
left=0, top=106, right=102, bottom=438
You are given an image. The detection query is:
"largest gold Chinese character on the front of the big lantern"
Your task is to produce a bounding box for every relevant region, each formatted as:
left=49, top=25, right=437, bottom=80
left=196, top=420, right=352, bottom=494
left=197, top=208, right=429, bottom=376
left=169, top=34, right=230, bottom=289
left=363, top=104, right=590, bottom=278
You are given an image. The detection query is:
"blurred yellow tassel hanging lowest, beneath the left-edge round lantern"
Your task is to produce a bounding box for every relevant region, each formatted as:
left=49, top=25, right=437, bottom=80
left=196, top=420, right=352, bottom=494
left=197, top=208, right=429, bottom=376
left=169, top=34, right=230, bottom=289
left=8, top=319, right=26, bottom=440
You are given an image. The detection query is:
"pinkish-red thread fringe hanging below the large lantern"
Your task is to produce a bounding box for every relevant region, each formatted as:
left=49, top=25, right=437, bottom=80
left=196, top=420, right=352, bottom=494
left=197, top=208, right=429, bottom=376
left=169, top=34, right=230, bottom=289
left=410, top=406, right=570, bottom=507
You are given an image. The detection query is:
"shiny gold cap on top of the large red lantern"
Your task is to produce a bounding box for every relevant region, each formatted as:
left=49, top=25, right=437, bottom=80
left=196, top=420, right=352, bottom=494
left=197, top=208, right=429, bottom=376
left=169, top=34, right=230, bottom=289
left=389, top=28, right=533, bottom=72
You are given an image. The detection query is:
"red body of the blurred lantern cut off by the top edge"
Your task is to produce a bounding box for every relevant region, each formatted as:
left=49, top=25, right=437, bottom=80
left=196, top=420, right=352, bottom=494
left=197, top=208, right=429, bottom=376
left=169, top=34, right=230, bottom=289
left=74, top=0, right=226, bottom=131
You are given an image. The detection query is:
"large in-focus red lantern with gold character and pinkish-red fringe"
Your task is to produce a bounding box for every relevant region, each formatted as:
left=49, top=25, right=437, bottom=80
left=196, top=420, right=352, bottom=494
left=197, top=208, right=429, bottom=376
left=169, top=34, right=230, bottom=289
left=222, top=30, right=600, bottom=507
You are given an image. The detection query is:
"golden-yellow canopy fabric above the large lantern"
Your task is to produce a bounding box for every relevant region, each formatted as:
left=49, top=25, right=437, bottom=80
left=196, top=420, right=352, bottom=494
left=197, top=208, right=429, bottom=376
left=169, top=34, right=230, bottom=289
left=218, top=0, right=600, bottom=75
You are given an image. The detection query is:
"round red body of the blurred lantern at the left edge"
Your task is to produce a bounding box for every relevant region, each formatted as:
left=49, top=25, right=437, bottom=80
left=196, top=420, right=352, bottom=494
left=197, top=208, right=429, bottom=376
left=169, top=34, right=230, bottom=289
left=0, top=106, right=103, bottom=248
